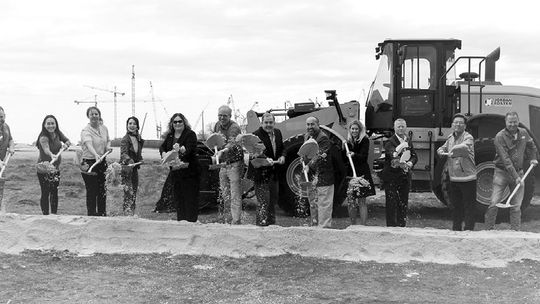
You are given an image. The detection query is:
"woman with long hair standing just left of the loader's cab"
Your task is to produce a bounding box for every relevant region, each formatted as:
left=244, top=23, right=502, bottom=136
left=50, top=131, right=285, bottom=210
left=345, top=120, right=375, bottom=225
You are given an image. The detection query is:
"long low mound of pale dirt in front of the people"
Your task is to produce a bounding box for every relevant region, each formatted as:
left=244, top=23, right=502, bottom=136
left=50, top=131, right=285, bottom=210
left=0, top=214, right=540, bottom=267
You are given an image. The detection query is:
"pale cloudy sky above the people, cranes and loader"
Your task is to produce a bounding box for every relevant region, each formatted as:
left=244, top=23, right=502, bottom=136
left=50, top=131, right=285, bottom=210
left=0, top=0, right=540, bottom=143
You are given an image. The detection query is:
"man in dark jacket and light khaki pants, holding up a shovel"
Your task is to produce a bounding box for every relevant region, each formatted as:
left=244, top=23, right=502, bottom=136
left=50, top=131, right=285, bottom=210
left=305, top=117, right=345, bottom=228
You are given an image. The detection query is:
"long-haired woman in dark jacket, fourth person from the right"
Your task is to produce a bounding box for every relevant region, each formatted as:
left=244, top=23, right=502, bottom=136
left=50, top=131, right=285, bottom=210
left=345, top=120, right=375, bottom=225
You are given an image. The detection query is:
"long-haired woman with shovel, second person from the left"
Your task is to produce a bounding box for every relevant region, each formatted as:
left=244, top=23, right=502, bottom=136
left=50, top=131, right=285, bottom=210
left=36, top=115, right=71, bottom=215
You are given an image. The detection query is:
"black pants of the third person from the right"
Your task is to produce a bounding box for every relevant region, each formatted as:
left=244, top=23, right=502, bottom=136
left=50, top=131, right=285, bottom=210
left=384, top=177, right=410, bottom=227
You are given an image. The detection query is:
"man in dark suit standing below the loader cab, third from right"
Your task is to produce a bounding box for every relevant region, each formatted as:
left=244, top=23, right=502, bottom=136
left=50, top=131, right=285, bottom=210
left=381, top=118, right=418, bottom=227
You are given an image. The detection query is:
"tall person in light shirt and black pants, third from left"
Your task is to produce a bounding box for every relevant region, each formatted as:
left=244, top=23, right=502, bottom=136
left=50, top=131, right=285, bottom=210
left=81, top=107, right=112, bottom=216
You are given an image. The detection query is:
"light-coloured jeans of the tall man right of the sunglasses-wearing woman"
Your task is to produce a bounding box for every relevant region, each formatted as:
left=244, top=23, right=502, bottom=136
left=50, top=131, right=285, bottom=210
left=219, top=162, right=243, bottom=224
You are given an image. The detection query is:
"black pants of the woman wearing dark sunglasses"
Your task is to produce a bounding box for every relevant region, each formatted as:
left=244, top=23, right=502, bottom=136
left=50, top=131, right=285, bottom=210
left=172, top=169, right=199, bottom=222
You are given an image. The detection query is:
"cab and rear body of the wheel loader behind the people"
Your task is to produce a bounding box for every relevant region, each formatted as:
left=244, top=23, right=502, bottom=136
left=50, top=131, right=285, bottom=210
left=365, top=39, right=540, bottom=208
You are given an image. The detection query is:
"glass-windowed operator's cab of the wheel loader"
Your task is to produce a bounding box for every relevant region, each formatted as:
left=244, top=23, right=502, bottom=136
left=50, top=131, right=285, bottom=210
left=365, top=39, right=461, bottom=133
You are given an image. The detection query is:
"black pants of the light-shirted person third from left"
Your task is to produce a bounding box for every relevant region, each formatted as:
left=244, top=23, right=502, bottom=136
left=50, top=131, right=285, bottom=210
left=81, top=159, right=107, bottom=216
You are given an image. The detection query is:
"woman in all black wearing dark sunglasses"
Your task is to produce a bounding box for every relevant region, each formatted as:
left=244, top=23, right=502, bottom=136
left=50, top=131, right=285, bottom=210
left=160, top=113, right=200, bottom=222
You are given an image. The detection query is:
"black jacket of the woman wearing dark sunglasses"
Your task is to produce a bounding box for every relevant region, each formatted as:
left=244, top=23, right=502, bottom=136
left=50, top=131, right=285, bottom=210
left=159, top=130, right=200, bottom=177
